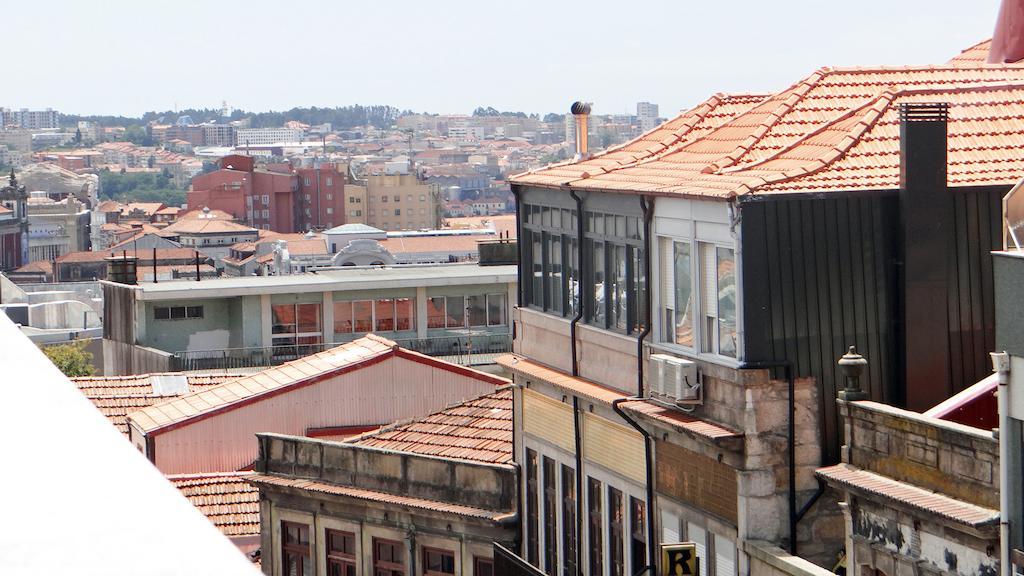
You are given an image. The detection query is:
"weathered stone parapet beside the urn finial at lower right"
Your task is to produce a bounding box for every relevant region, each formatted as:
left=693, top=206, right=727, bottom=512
left=839, top=401, right=999, bottom=509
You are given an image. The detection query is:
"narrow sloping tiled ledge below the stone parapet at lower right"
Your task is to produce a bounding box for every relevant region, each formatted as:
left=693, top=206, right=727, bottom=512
left=817, top=464, right=999, bottom=528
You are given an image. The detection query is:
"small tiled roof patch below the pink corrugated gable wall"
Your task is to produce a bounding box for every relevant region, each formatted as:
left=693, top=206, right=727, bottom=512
left=167, top=472, right=259, bottom=538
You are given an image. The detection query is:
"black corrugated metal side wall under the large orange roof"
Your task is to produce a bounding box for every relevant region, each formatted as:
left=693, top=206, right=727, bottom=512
left=740, top=189, right=1005, bottom=462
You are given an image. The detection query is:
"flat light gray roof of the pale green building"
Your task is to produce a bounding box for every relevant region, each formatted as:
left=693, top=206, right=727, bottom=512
left=110, top=263, right=517, bottom=301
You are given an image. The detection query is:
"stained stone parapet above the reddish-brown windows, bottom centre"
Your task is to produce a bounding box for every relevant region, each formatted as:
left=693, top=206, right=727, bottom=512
left=256, top=434, right=516, bottom=511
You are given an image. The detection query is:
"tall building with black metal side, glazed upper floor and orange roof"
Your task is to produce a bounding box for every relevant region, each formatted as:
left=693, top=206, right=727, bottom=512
left=500, top=40, right=1024, bottom=576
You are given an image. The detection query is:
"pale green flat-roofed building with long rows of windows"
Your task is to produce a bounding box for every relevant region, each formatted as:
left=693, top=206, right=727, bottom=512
left=103, top=260, right=516, bottom=374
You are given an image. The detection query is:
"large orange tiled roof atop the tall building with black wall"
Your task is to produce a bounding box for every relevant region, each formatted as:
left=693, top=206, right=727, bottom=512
left=510, top=46, right=1024, bottom=199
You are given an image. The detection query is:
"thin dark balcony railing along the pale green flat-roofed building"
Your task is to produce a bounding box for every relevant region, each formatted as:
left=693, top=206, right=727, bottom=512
left=170, top=333, right=512, bottom=371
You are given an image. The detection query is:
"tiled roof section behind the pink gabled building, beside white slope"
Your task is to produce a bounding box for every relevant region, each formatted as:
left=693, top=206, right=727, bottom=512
left=72, top=373, right=242, bottom=436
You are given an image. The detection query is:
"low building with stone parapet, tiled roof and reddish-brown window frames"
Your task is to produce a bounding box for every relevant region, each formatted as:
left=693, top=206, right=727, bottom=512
left=248, top=386, right=517, bottom=576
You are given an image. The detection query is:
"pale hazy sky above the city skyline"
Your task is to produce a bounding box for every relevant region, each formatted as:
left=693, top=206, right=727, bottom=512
left=0, top=0, right=998, bottom=116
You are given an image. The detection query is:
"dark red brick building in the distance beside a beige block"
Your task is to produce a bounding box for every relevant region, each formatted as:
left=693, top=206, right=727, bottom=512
left=188, top=155, right=345, bottom=233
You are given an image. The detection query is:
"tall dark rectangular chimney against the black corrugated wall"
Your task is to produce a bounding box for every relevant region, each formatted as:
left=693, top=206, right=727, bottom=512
left=899, top=102, right=955, bottom=411
